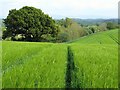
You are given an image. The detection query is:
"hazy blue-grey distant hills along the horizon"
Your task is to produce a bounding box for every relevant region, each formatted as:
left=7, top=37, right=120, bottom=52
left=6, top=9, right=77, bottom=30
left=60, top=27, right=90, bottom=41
left=72, top=18, right=118, bottom=25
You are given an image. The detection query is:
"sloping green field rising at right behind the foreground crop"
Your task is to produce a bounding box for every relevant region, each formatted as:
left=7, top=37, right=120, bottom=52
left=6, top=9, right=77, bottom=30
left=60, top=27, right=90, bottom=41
left=69, top=29, right=119, bottom=44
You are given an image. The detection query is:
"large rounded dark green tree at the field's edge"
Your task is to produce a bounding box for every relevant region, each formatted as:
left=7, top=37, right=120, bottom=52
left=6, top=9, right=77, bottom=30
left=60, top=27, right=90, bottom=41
left=2, top=6, right=59, bottom=41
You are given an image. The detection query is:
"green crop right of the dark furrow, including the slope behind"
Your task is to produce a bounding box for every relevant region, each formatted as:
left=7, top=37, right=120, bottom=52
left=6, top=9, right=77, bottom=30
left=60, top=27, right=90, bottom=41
left=71, top=30, right=118, bottom=88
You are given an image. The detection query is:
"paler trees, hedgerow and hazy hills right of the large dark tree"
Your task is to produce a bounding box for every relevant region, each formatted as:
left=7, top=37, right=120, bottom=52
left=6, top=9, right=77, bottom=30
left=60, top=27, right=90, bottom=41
left=56, top=18, right=119, bottom=42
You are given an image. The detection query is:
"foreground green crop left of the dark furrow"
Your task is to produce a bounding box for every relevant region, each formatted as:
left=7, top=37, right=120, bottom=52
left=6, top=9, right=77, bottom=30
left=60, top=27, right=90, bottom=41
left=2, top=42, right=67, bottom=88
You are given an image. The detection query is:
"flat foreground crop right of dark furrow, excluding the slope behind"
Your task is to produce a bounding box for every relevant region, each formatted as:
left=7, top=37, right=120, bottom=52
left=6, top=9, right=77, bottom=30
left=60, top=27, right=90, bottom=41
left=71, top=45, right=118, bottom=88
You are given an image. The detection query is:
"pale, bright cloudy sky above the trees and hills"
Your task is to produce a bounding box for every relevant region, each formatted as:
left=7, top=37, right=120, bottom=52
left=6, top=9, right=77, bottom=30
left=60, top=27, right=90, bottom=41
left=0, top=0, right=119, bottom=19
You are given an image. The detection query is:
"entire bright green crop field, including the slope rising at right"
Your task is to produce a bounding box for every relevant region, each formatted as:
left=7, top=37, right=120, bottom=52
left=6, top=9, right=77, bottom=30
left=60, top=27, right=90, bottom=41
left=0, top=30, right=119, bottom=88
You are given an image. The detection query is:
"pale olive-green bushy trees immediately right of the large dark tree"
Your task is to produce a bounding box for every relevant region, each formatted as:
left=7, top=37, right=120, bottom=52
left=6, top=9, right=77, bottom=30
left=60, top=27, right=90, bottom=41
left=57, top=18, right=87, bottom=42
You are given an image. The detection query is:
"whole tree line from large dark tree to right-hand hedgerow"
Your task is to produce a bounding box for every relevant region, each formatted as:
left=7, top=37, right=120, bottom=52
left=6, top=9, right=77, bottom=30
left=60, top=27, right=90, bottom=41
left=2, top=6, right=119, bottom=42
